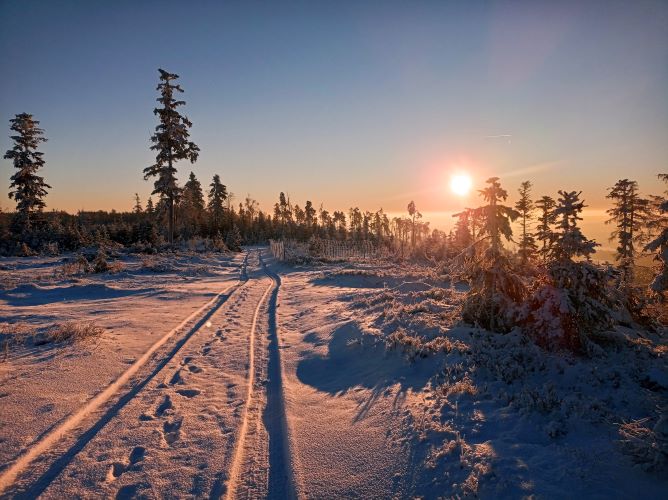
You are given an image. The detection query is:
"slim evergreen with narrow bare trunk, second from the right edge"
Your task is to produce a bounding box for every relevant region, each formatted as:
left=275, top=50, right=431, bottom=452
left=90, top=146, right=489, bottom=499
left=605, top=179, right=649, bottom=285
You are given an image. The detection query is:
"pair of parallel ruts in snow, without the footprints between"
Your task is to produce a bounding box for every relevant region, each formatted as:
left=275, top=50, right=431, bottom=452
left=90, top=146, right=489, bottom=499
left=0, top=250, right=301, bottom=499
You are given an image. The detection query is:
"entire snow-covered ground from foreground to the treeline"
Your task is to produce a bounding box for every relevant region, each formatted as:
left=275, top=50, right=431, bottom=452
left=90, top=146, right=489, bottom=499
left=0, top=249, right=668, bottom=498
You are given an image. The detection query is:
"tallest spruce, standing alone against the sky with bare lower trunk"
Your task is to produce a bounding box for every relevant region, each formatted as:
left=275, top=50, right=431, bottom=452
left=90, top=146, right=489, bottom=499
left=144, top=69, right=199, bottom=245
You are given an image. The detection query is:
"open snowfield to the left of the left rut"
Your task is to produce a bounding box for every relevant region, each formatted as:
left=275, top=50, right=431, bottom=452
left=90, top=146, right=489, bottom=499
left=0, top=253, right=241, bottom=470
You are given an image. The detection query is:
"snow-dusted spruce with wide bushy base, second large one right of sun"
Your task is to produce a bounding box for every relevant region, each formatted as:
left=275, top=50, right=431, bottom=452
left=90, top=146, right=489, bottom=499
left=522, top=191, right=619, bottom=353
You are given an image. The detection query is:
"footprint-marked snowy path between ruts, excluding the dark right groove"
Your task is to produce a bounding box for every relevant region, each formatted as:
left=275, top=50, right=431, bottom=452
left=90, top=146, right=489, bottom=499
left=3, top=253, right=290, bottom=498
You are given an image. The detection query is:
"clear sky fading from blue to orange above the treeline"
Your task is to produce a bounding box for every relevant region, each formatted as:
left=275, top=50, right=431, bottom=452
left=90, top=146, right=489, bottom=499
left=0, top=0, right=668, bottom=238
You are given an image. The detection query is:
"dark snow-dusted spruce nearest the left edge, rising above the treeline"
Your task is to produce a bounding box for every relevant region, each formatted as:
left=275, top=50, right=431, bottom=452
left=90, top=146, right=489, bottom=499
left=4, top=113, right=51, bottom=234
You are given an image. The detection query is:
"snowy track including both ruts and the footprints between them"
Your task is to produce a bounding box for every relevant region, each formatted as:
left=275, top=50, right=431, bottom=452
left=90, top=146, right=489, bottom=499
left=0, top=250, right=301, bottom=499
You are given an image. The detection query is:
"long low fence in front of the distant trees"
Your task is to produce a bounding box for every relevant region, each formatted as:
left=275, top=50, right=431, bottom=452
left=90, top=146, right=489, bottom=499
left=269, top=238, right=393, bottom=260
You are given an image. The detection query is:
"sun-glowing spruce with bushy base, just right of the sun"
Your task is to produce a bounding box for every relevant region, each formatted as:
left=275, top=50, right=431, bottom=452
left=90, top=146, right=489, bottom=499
left=462, top=177, right=526, bottom=332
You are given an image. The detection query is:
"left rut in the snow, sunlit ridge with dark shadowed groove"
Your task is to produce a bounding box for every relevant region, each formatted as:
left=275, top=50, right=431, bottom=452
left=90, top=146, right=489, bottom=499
left=0, top=252, right=250, bottom=498
